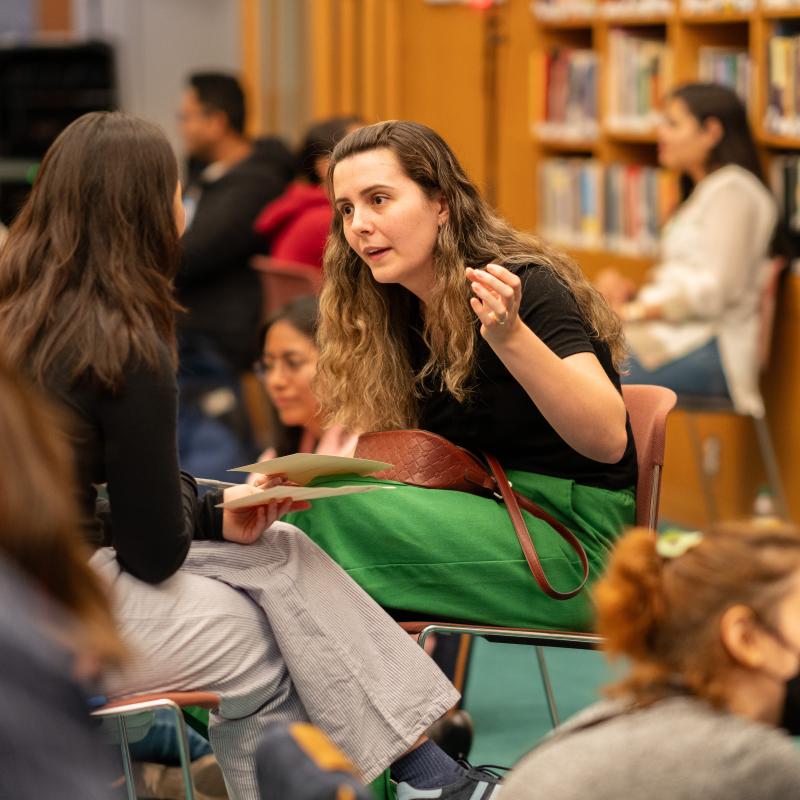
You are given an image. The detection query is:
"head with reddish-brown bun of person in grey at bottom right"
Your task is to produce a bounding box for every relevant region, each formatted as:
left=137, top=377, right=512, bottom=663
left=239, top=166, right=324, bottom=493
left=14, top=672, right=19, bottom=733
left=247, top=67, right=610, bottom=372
left=594, top=522, right=800, bottom=724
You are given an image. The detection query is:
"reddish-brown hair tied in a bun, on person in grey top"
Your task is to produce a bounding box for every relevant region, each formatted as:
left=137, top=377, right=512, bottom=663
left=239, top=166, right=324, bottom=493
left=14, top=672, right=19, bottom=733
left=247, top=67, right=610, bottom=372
left=594, top=522, right=800, bottom=707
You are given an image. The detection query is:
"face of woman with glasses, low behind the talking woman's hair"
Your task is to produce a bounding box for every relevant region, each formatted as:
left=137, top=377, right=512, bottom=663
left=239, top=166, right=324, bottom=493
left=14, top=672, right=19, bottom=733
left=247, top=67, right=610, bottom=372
left=261, top=320, right=319, bottom=427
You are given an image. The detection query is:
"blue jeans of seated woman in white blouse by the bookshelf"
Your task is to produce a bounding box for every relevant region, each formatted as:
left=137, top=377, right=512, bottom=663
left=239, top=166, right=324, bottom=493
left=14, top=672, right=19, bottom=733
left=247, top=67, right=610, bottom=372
left=622, top=339, right=730, bottom=399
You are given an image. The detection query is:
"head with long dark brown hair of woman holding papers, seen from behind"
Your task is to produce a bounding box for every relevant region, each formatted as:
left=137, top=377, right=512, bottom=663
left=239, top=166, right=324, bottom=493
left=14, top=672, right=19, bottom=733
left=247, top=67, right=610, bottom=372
left=0, top=111, right=184, bottom=387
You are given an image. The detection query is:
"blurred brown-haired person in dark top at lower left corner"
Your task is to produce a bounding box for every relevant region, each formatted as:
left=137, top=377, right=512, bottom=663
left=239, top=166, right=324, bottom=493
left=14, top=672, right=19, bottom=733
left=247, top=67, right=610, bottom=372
left=0, top=364, right=126, bottom=800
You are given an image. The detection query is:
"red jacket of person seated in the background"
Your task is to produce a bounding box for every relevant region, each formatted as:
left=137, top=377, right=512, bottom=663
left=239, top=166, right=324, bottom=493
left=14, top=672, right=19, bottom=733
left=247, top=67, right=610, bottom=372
left=255, top=183, right=333, bottom=267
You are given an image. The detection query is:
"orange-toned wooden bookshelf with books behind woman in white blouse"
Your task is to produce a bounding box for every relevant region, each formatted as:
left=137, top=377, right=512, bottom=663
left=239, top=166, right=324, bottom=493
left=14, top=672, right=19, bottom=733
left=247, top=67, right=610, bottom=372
left=527, top=0, right=800, bottom=524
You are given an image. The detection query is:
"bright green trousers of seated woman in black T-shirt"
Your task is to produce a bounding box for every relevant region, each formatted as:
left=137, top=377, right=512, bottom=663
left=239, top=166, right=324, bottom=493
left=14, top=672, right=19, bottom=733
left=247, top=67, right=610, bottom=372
left=286, top=471, right=635, bottom=630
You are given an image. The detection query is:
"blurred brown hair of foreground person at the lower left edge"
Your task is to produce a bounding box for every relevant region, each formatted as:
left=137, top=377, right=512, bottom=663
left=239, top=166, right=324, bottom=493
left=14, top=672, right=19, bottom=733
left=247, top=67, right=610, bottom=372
left=0, top=364, right=124, bottom=673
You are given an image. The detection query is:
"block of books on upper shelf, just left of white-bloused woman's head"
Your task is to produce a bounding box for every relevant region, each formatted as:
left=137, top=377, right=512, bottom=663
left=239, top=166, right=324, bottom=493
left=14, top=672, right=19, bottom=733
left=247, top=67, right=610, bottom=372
left=604, top=28, right=672, bottom=132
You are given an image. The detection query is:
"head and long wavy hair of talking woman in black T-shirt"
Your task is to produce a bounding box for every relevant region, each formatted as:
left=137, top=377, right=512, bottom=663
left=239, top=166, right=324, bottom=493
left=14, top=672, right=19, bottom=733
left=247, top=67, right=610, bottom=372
left=317, top=121, right=624, bottom=431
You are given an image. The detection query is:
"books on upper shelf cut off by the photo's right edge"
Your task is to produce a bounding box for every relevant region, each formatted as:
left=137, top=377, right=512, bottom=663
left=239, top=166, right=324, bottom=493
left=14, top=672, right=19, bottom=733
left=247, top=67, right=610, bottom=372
left=764, top=24, right=800, bottom=136
